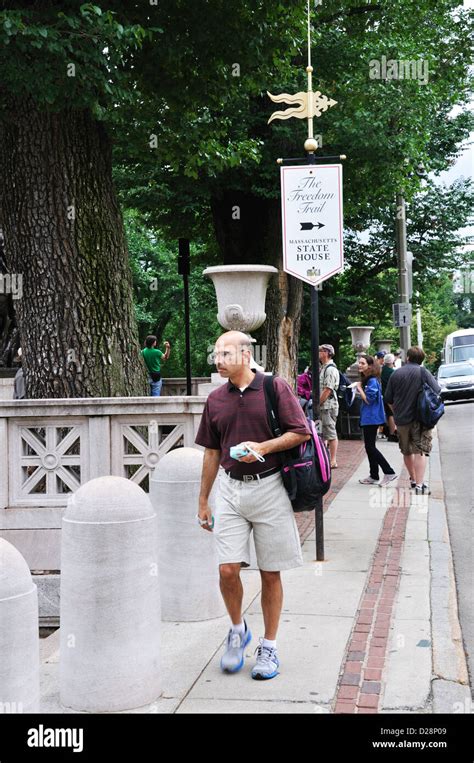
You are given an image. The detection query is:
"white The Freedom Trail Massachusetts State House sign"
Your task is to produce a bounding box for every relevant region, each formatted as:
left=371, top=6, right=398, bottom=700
left=281, top=164, right=344, bottom=286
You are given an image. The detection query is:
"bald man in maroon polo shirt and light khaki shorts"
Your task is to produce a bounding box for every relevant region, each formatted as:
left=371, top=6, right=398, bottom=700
left=196, top=331, right=310, bottom=680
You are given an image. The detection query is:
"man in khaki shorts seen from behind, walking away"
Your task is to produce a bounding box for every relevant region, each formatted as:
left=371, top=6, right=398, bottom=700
left=384, top=347, right=441, bottom=495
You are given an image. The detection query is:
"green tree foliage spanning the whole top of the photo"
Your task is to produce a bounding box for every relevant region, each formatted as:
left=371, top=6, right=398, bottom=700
left=0, top=0, right=472, bottom=388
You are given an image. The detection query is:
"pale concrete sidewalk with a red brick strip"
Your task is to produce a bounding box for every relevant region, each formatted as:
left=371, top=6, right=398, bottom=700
left=41, top=440, right=471, bottom=713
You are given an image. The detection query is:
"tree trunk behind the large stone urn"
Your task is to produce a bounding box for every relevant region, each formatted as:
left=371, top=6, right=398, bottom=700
left=211, top=191, right=303, bottom=385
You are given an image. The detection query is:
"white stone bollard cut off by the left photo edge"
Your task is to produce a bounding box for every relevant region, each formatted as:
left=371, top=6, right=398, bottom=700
left=0, top=538, right=39, bottom=714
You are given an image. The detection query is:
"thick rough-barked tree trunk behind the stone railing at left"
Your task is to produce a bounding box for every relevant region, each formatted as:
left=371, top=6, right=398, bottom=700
left=0, top=100, right=146, bottom=398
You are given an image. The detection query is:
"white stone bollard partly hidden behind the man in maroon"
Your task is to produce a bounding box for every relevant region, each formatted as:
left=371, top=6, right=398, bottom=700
left=150, top=448, right=226, bottom=621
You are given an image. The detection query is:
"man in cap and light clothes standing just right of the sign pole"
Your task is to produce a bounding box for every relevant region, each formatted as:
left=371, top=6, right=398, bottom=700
left=319, top=344, right=340, bottom=469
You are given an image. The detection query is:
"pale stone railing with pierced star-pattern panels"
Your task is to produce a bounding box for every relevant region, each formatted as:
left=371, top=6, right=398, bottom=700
left=0, top=396, right=206, bottom=529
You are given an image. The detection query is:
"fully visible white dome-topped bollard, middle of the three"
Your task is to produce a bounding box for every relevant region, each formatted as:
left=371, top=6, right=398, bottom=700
left=60, top=477, right=161, bottom=712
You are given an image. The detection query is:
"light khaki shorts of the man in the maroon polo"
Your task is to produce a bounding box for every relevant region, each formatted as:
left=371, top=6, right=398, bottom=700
left=214, top=469, right=303, bottom=572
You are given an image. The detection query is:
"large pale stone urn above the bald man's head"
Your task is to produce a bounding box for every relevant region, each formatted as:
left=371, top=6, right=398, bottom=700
left=204, top=265, right=278, bottom=333
